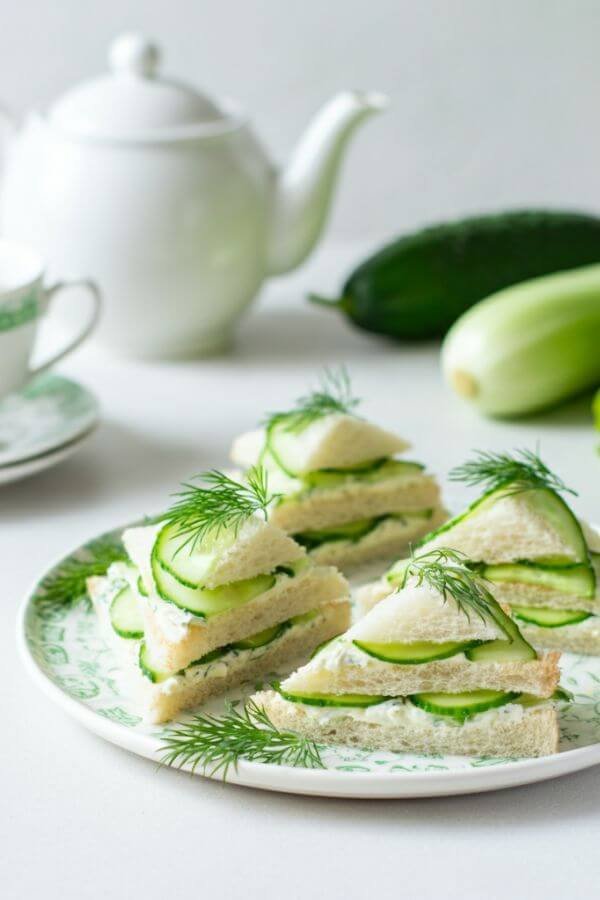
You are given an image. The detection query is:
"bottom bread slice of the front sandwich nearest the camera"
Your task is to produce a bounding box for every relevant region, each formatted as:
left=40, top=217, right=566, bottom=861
left=253, top=691, right=558, bottom=758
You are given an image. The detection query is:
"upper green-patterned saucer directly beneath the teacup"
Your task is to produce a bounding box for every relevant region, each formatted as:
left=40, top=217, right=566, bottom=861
left=0, top=375, right=99, bottom=468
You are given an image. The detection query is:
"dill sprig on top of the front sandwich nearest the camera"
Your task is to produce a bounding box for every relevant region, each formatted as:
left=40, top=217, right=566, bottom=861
left=400, top=547, right=501, bottom=622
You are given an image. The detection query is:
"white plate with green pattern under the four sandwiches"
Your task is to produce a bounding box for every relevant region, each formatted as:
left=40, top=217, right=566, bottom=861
left=18, top=529, right=600, bottom=798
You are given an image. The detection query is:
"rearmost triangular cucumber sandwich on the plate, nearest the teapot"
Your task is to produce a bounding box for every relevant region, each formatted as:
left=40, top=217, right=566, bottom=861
left=231, top=370, right=447, bottom=568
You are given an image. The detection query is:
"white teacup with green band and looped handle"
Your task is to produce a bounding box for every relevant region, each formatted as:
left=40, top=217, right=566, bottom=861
left=0, top=240, right=100, bottom=398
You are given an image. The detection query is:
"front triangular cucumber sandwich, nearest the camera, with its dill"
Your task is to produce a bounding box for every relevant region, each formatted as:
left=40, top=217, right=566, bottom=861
left=253, top=549, right=566, bottom=757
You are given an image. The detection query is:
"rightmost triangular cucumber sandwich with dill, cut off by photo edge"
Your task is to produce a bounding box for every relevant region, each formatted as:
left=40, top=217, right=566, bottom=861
left=361, top=450, right=600, bottom=655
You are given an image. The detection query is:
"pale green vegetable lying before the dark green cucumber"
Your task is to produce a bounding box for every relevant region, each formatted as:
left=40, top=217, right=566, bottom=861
left=442, top=265, right=600, bottom=416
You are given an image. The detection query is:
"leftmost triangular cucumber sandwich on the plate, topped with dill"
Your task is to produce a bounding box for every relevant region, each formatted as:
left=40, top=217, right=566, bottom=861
left=88, top=469, right=349, bottom=722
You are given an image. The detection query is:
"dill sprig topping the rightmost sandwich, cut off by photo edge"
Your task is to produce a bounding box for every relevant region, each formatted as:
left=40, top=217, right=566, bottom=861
left=449, top=450, right=577, bottom=496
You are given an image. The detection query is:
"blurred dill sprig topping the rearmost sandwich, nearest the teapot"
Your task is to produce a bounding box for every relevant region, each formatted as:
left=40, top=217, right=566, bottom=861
left=264, top=366, right=360, bottom=431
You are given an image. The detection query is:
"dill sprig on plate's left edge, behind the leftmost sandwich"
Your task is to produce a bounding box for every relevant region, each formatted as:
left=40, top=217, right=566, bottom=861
left=39, top=538, right=127, bottom=606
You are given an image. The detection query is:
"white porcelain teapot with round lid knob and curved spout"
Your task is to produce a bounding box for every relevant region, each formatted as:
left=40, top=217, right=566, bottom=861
left=0, top=35, right=385, bottom=358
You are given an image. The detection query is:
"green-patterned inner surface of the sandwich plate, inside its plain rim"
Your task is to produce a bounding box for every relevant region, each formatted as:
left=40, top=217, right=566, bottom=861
left=26, top=531, right=600, bottom=774
